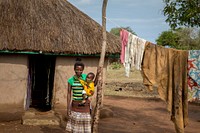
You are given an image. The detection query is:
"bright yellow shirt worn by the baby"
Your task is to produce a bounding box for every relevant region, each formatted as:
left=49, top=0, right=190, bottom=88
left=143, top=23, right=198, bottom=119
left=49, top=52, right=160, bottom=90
left=79, top=79, right=94, bottom=96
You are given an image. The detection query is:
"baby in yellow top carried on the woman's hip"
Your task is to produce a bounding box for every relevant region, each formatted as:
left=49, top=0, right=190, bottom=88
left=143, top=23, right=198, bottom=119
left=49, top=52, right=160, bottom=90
left=79, top=72, right=95, bottom=106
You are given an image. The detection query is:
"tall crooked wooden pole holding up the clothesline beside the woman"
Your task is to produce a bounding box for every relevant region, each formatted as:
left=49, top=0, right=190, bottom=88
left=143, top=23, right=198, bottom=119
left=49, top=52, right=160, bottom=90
left=92, top=0, right=108, bottom=133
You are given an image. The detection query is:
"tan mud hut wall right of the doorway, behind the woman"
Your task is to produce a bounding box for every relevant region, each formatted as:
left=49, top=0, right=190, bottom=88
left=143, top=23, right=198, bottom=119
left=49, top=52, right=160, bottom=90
left=53, top=57, right=107, bottom=110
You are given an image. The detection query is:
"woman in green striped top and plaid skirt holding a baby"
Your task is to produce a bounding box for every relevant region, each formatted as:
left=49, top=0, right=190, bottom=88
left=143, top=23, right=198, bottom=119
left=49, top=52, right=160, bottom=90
left=66, top=62, right=99, bottom=133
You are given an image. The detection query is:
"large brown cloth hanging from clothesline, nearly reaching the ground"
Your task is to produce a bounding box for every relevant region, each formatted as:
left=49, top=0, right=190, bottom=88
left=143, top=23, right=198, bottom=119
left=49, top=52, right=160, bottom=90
left=142, top=42, right=188, bottom=133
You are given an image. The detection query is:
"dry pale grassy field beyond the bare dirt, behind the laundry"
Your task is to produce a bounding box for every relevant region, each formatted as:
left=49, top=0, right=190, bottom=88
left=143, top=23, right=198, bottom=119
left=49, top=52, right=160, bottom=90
left=104, top=66, right=158, bottom=97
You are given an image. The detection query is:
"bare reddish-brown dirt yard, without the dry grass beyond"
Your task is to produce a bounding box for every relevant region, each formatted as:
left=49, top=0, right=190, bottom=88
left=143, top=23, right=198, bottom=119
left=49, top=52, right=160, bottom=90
left=0, top=96, right=200, bottom=133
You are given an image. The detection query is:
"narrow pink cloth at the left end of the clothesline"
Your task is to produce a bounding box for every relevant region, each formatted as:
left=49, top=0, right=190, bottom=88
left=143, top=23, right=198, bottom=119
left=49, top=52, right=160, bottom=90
left=120, top=29, right=129, bottom=64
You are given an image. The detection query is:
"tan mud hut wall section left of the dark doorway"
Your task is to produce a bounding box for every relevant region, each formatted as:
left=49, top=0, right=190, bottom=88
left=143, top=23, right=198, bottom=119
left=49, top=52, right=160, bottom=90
left=0, top=55, right=28, bottom=120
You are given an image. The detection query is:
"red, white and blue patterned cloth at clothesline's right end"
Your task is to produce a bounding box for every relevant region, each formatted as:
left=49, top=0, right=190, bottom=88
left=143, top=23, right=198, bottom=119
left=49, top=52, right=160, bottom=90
left=188, top=50, right=200, bottom=101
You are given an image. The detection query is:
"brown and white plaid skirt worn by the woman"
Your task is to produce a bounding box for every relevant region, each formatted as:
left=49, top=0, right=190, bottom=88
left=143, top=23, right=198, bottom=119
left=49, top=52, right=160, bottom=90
left=66, top=111, right=91, bottom=133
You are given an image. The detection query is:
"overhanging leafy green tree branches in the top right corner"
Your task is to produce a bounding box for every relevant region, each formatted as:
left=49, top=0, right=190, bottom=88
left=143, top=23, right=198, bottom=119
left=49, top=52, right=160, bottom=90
left=163, top=0, right=200, bottom=29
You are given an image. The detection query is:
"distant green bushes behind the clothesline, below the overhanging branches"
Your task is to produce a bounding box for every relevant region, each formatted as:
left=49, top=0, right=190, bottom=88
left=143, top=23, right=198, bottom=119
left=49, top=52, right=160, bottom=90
left=156, top=28, right=200, bottom=50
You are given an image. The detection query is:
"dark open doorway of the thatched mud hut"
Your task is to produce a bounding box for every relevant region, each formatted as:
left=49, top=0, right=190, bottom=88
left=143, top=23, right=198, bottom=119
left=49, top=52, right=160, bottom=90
left=27, top=55, right=55, bottom=111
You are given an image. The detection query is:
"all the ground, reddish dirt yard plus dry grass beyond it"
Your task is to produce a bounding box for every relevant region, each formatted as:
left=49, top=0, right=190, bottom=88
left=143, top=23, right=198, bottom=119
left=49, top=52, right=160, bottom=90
left=0, top=67, right=200, bottom=133
